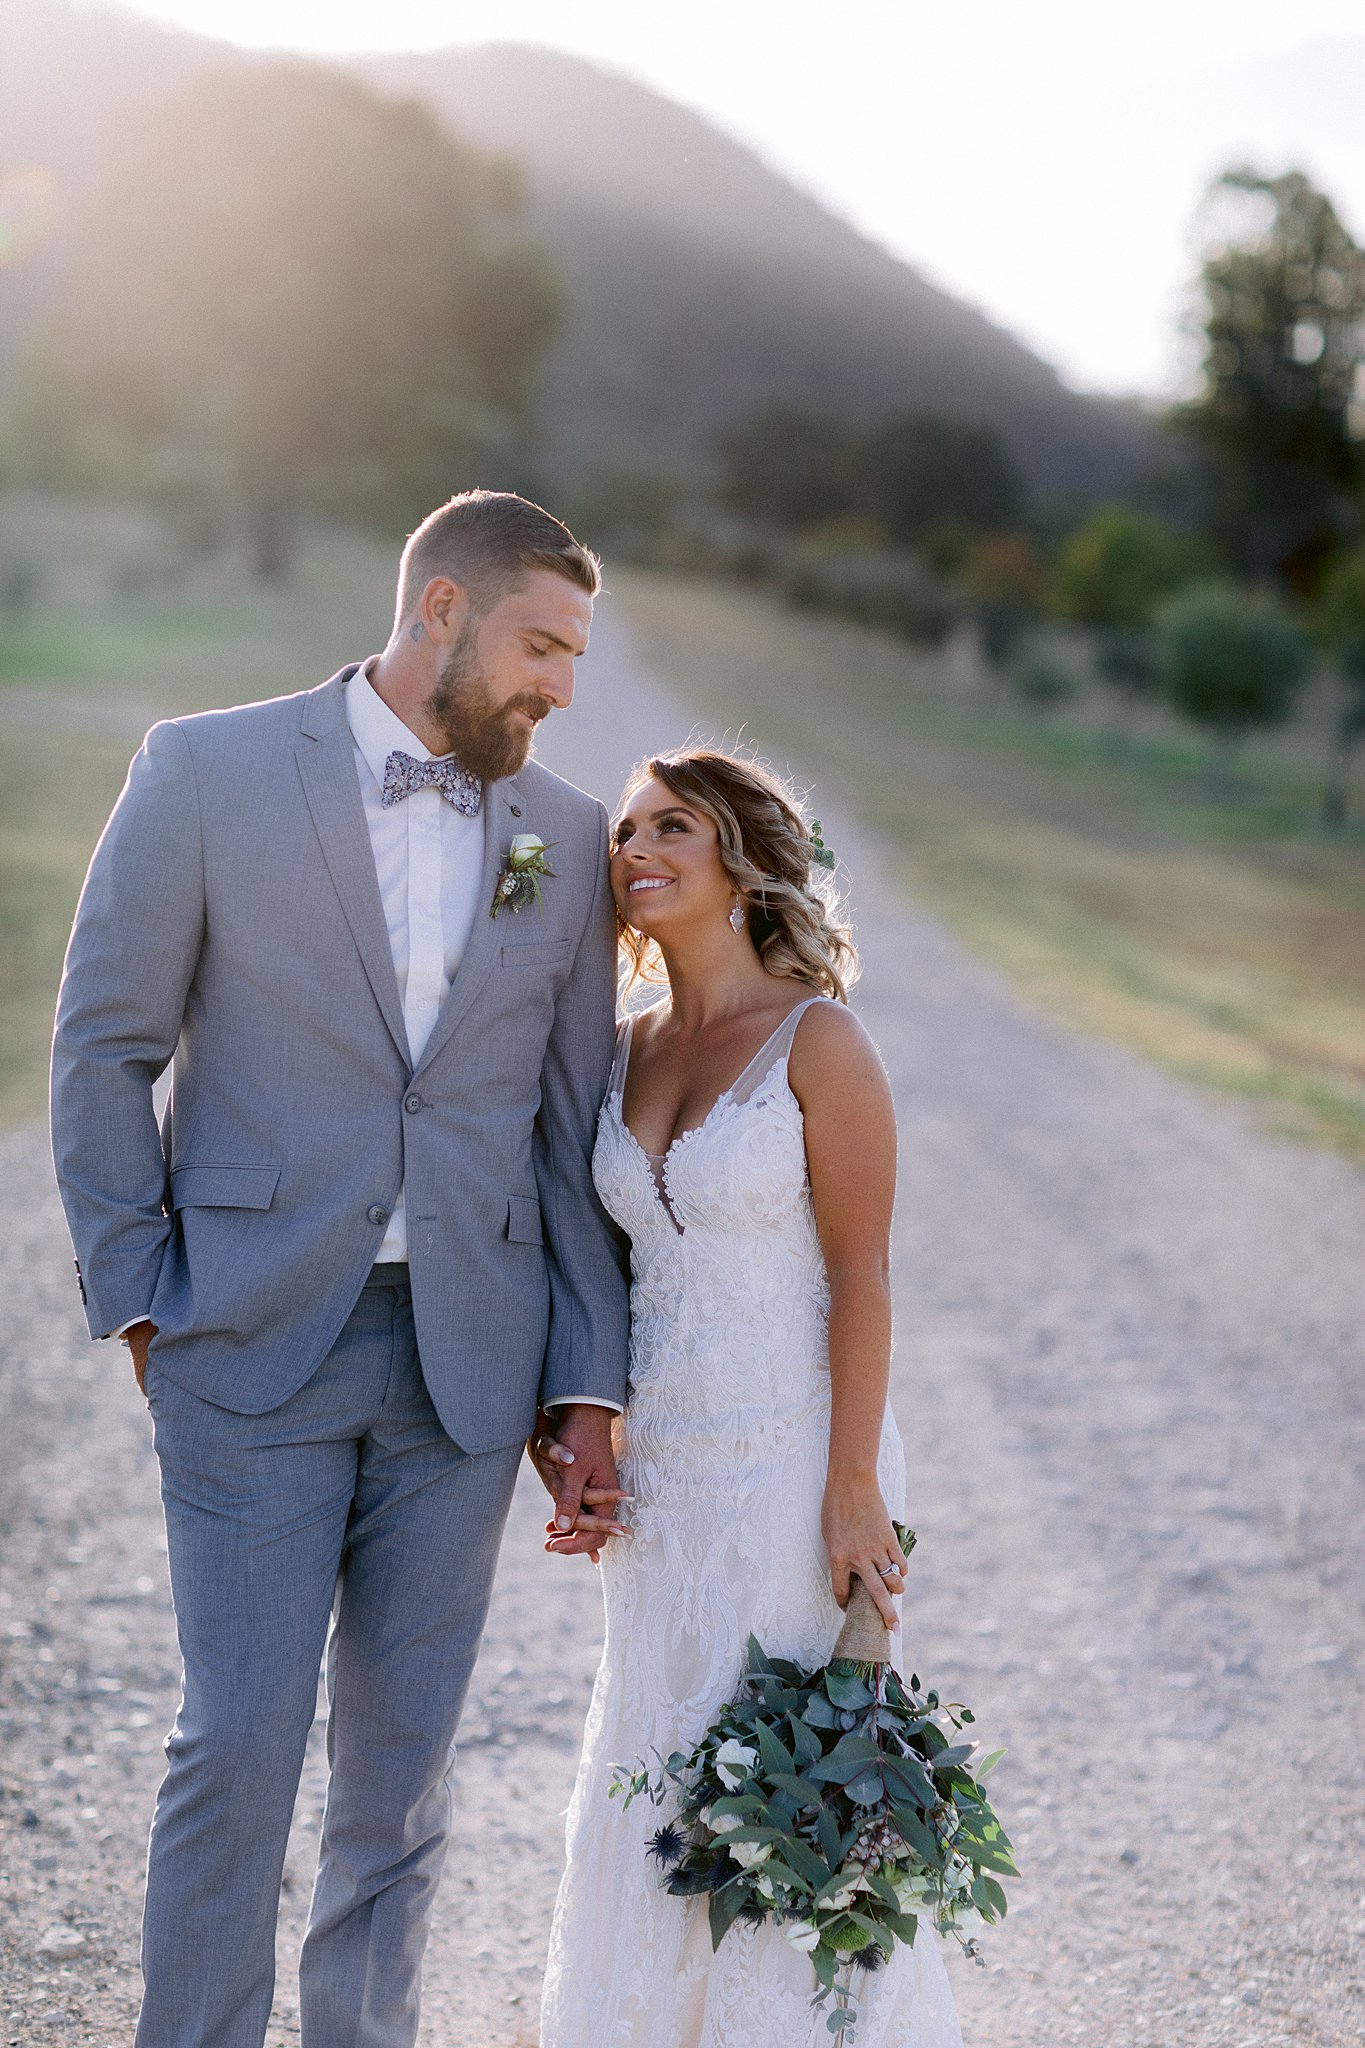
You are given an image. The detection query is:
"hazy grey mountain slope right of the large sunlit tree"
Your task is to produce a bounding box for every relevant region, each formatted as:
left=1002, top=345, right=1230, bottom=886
left=360, top=45, right=1152, bottom=496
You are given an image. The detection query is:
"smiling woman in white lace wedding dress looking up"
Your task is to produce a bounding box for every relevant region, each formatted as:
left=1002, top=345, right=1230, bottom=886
left=540, top=750, right=962, bottom=2048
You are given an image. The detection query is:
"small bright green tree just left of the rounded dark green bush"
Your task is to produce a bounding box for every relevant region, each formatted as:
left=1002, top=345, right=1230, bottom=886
left=1054, top=504, right=1185, bottom=705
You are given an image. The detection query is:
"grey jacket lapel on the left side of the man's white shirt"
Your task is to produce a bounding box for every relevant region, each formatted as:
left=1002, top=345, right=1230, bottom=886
left=297, top=668, right=409, bottom=1065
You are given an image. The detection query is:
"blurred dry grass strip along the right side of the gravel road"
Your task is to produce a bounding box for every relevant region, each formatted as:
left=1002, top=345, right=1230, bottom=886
left=612, top=573, right=1365, bottom=1159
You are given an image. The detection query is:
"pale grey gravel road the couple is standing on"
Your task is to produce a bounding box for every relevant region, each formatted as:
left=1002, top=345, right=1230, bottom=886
left=0, top=618, right=1365, bottom=2048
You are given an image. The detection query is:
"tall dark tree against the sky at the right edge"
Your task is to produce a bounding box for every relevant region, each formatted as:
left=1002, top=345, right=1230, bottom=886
left=1177, top=170, right=1365, bottom=596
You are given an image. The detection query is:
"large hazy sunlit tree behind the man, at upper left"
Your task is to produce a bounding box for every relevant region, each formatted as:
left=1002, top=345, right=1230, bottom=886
left=17, top=59, right=559, bottom=575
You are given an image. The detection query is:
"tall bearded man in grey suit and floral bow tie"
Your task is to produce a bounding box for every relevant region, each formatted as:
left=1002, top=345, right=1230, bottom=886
left=53, top=492, right=626, bottom=2048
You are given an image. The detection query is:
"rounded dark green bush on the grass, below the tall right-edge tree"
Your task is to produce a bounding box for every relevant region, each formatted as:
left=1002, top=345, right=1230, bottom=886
left=1156, top=584, right=1312, bottom=774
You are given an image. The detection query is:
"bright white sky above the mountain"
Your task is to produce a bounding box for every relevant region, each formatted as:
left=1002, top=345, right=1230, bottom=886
left=120, top=0, right=1365, bottom=393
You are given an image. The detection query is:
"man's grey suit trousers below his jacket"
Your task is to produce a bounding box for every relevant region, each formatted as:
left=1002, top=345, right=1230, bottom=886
left=137, top=1268, right=520, bottom=2048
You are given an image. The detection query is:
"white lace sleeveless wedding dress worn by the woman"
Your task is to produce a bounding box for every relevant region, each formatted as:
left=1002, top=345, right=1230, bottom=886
left=540, top=997, right=962, bottom=2048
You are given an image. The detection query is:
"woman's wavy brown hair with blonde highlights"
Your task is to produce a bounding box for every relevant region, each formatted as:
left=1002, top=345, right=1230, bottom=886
left=616, top=748, right=857, bottom=1004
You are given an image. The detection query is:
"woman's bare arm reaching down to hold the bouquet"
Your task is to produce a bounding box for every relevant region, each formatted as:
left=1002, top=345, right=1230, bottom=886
left=788, top=1004, right=902, bottom=1628
